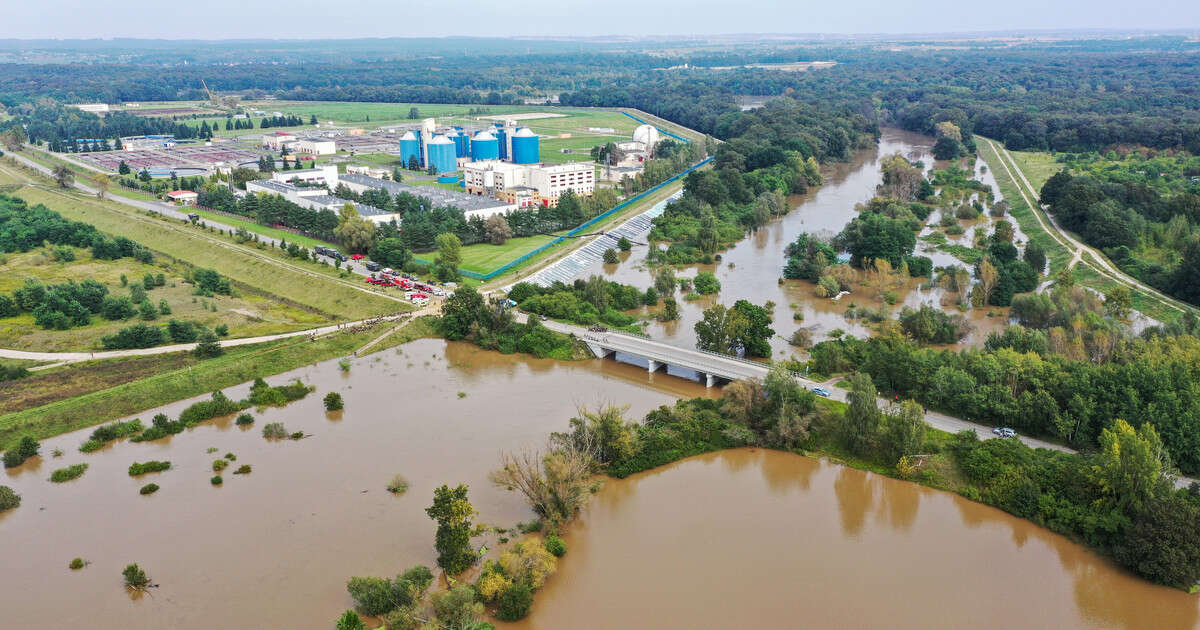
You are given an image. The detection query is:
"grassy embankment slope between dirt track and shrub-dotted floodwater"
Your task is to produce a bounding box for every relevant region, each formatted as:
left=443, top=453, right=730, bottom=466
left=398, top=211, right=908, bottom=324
left=0, top=330, right=379, bottom=449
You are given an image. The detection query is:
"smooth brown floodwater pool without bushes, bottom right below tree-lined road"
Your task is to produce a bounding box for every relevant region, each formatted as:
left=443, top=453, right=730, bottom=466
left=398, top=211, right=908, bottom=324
left=503, top=449, right=1200, bottom=630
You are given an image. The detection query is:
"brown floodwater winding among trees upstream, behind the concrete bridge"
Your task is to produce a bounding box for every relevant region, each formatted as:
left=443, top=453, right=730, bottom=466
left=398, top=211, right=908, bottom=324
left=580, top=128, right=1025, bottom=359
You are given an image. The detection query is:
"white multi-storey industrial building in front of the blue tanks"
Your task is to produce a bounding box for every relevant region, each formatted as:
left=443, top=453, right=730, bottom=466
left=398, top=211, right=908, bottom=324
left=462, top=159, right=595, bottom=206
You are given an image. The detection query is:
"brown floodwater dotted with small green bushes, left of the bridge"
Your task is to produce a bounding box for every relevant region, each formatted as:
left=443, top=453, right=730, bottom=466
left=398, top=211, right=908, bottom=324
left=0, top=340, right=715, bottom=629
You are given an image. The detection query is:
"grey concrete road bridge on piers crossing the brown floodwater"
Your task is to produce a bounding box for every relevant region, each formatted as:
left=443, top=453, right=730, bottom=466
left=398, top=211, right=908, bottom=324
left=576, top=331, right=769, bottom=388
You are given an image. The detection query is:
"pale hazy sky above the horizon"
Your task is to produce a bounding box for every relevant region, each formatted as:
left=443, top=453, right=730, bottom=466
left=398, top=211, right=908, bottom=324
left=7, top=0, right=1200, bottom=40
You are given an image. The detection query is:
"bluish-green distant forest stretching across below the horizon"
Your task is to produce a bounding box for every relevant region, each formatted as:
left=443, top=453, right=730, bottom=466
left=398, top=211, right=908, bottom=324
left=0, top=37, right=1200, bottom=152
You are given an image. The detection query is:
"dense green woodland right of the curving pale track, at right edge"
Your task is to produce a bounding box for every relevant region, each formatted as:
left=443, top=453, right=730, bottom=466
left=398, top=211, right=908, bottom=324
left=1042, top=151, right=1200, bottom=304
